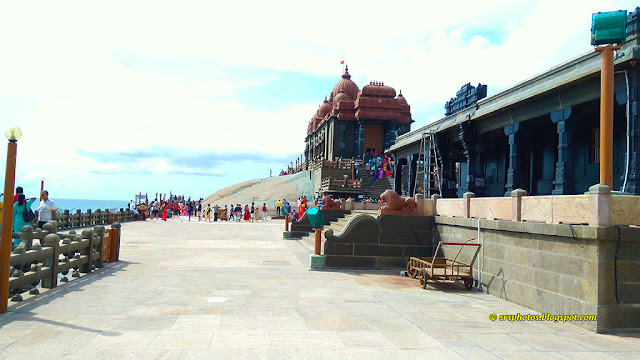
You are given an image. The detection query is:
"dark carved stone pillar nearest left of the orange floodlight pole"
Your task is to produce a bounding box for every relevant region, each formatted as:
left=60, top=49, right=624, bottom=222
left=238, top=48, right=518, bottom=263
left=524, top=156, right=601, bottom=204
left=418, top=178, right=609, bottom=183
left=551, top=107, right=576, bottom=195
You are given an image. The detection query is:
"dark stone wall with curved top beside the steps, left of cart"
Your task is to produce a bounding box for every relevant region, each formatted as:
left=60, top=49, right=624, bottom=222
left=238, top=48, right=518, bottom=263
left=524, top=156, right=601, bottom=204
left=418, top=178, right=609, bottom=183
left=324, top=214, right=433, bottom=269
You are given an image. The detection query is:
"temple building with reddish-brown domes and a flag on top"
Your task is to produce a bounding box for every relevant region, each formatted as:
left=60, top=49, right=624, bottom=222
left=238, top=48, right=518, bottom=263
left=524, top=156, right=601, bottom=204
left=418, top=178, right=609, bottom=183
left=305, top=67, right=412, bottom=161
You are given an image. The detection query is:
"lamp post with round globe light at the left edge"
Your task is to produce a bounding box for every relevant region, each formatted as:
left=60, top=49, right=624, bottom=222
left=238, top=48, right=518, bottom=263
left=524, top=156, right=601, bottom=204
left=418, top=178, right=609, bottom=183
left=0, top=126, right=22, bottom=314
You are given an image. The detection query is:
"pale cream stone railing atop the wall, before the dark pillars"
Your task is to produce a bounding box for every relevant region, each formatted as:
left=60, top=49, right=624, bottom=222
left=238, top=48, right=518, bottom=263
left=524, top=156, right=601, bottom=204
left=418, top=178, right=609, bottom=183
left=417, top=185, right=640, bottom=227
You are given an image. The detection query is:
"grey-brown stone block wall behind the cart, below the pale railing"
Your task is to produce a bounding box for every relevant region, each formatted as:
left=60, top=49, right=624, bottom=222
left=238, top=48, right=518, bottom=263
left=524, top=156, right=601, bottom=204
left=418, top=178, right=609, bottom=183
left=433, top=216, right=640, bottom=332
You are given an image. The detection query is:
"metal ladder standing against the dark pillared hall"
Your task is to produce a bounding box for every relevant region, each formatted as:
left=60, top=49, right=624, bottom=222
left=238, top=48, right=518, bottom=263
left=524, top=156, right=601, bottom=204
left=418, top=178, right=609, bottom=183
left=414, top=131, right=442, bottom=199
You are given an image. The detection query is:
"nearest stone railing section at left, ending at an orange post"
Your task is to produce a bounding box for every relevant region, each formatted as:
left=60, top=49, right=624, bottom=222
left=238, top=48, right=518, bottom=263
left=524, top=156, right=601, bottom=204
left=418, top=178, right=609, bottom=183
left=9, top=223, right=120, bottom=301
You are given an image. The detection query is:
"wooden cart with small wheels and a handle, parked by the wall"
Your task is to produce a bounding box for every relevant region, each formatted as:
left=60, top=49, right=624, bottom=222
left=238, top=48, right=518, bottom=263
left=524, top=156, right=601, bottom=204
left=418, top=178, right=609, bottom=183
left=407, top=238, right=480, bottom=290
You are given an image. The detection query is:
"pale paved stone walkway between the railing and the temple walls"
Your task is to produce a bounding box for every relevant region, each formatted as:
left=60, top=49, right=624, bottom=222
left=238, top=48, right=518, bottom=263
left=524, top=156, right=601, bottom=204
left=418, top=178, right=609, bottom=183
left=0, top=221, right=640, bottom=360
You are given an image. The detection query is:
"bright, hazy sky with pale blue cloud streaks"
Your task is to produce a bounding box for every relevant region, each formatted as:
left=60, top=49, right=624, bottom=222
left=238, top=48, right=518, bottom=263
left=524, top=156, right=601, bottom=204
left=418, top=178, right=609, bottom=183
left=0, top=0, right=637, bottom=200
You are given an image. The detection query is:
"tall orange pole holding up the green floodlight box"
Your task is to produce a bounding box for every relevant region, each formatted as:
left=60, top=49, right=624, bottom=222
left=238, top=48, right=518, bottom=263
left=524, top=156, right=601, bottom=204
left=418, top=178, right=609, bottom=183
left=596, top=46, right=620, bottom=188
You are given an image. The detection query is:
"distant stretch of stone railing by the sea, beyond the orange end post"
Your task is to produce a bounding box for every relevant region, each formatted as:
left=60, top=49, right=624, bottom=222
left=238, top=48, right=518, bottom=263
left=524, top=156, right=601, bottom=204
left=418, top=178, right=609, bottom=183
left=56, top=209, right=138, bottom=230
